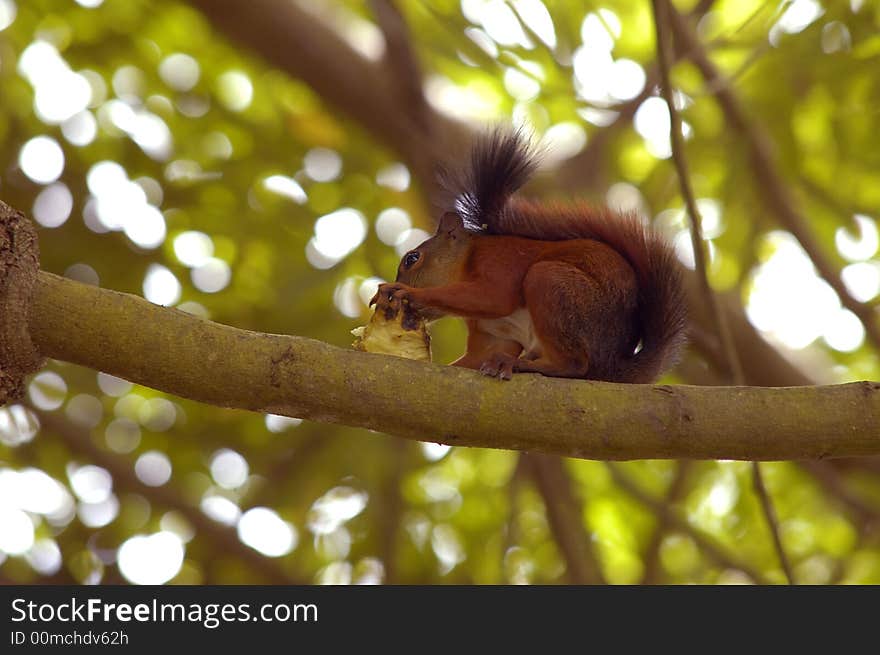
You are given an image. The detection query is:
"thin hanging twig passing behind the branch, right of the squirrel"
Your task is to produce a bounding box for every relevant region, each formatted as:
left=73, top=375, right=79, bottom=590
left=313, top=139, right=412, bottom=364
left=652, top=0, right=795, bottom=584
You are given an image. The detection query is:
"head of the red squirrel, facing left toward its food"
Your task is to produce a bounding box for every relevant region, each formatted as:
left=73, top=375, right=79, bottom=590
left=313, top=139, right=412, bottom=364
left=397, top=212, right=474, bottom=298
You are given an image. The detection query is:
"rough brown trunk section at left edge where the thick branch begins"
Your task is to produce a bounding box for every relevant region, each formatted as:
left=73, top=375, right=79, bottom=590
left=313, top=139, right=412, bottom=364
left=0, top=201, right=44, bottom=405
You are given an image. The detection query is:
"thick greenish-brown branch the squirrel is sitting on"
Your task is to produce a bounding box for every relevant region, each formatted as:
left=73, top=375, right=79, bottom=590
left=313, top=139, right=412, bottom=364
left=15, top=272, right=880, bottom=460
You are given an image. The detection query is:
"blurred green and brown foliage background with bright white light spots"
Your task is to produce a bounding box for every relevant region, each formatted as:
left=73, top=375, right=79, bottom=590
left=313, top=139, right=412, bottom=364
left=0, top=0, right=880, bottom=584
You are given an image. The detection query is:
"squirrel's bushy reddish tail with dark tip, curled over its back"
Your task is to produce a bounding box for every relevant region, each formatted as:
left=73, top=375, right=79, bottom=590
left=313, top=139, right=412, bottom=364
left=444, top=129, right=687, bottom=382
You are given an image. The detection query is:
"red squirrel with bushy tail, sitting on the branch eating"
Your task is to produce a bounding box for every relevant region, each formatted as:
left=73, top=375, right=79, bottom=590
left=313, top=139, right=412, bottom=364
left=370, top=129, right=686, bottom=383
